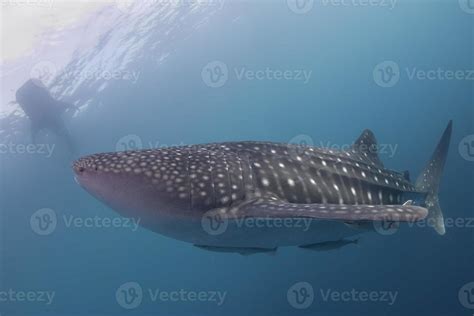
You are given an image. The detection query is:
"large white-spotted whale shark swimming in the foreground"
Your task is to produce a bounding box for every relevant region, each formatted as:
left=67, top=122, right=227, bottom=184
left=73, top=121, right=452, bottom=254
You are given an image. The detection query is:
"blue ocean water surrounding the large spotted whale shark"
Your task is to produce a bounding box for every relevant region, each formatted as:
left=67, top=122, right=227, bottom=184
left=0, top=0, right=474, bottom=316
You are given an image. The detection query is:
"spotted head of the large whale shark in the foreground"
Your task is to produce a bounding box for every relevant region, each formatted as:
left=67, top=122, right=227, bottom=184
left=73, top=150, right=190, bottom=221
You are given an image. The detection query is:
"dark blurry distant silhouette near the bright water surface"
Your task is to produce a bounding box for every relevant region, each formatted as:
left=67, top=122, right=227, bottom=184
left=16, top=79, right=77, bottom=152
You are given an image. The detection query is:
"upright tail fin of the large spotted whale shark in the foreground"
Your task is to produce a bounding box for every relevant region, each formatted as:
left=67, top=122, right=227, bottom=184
left=415, top=121, right=453, bottom=235
